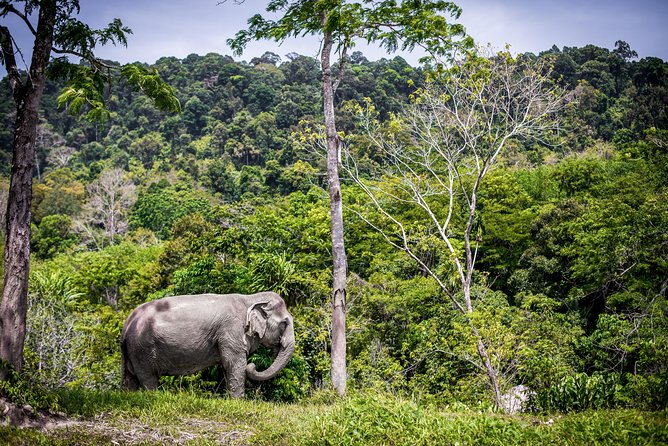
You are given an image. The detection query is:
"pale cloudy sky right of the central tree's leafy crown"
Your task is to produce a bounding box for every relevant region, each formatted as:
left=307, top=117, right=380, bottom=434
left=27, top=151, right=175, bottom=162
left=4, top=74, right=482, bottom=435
left=457, top=0, right=668, bottom=60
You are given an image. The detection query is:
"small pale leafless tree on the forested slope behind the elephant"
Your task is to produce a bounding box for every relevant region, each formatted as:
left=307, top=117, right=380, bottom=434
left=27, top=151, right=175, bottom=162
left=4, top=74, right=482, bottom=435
left=84, top=169, right=137, bottom=245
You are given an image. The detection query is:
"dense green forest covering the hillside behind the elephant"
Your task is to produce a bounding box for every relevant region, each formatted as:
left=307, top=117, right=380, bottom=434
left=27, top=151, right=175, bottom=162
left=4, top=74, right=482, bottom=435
left=0, top=38, right=668, bottom=410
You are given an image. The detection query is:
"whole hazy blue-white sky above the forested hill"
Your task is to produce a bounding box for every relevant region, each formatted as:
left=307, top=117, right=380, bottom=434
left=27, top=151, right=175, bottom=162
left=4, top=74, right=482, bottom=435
left=0, top=0, right=668, bottom=75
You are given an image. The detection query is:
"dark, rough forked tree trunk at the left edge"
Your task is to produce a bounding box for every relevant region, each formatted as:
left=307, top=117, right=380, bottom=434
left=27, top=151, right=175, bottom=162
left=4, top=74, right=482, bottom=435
left=0, top=0, right=56, bottom=379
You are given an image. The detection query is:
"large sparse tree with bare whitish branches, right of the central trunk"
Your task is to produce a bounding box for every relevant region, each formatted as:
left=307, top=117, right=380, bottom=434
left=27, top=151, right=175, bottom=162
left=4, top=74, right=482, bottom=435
left=344, top=49, right=563, bottom=406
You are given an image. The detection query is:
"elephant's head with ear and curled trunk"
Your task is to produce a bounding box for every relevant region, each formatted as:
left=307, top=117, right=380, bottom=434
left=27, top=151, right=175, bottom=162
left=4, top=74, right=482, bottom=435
left=246, top=298, right=295, bottom=381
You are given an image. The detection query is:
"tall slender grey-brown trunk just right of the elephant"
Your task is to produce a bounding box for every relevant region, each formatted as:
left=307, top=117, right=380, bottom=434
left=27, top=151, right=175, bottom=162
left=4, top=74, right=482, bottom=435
left=321, top=32, right=347, bottom=397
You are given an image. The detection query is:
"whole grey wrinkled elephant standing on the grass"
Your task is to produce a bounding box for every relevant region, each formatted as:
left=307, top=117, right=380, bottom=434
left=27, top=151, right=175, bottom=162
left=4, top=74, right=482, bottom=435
left=121, top=292, right=295, bottom=398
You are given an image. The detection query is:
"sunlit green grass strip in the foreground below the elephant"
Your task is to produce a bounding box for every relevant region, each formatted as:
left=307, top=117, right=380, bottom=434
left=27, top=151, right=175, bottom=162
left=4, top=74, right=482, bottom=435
left=0, top=391, right=668, bottom=446
